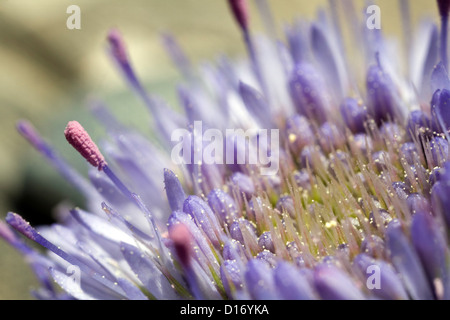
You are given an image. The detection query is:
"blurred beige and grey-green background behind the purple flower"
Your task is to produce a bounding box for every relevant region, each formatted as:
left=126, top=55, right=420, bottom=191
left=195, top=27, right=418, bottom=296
left=0, top=0, right=437, bottom=299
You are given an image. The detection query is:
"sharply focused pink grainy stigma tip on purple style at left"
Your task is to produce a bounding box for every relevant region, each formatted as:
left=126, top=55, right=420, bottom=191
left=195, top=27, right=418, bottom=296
left=64, top=121, right=106, bottom=171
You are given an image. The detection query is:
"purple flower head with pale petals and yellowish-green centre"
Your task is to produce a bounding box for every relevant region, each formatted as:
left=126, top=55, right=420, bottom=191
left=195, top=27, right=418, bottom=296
left=0, top=0, right=450, bottom=300
